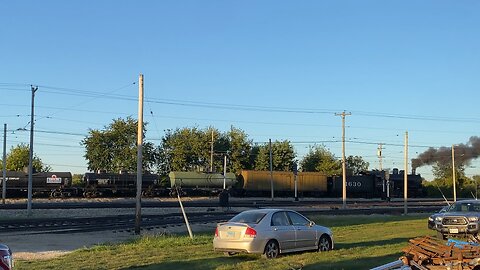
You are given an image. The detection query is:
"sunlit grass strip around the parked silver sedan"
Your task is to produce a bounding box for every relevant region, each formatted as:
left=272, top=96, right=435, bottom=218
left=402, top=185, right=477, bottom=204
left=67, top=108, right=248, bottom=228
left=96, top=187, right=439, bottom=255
left=15, top=215, right=433, bottom=270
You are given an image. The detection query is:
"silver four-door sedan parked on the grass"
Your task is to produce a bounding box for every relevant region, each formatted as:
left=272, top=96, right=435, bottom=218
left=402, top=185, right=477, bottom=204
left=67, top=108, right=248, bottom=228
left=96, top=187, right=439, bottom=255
left=213, top=209, right=334, bottom=258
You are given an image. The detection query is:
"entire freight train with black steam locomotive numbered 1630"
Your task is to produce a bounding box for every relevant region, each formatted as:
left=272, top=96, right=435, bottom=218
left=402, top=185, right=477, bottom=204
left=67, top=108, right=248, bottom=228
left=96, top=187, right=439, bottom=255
left=0, top=169, right=423, bottom=198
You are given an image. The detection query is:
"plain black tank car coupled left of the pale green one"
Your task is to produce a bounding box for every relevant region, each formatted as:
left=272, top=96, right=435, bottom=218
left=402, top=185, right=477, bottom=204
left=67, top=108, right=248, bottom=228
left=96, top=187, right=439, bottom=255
left=83, top=171, right=164, bottom=198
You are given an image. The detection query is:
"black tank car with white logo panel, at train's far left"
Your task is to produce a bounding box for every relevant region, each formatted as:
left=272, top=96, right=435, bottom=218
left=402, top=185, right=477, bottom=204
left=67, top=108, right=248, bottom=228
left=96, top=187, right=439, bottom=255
left=0, top=171, right=77, bottom=197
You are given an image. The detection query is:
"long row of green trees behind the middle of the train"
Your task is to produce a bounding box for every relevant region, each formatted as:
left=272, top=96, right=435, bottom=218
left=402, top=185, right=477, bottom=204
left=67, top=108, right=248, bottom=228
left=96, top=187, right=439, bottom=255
left=81, top=117, right=369, bottom=175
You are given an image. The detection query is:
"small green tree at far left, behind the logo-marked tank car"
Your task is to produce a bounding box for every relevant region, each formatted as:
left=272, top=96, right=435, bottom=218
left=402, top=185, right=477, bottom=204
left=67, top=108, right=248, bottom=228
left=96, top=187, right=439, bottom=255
left=0, top=144, right=51, bottom=172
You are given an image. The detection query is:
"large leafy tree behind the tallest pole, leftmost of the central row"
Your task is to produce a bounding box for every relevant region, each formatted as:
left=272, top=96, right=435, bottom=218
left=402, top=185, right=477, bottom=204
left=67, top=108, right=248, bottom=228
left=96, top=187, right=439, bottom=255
left=81, top=117, right=157, bottom=172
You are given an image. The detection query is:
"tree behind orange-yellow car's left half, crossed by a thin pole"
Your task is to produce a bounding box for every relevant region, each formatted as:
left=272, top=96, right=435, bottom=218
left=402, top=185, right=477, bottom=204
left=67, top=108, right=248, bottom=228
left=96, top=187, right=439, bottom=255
left=255, top=140, right=295, bottom=171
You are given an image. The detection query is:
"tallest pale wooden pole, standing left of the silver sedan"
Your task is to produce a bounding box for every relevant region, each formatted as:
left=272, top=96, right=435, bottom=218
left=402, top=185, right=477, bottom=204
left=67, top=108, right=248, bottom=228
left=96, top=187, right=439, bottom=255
left=135, top=74, right=143, bottom=234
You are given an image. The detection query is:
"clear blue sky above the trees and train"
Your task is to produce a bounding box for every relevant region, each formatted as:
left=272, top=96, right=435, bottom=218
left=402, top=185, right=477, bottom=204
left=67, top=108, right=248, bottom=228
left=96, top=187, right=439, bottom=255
left=0, top=0, right=480, bottom=179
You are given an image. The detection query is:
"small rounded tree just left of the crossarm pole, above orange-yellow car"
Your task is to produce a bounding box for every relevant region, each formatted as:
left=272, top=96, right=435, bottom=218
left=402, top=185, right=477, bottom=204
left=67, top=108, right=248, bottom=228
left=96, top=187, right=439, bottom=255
left=300, top=146, right=342, bottom=175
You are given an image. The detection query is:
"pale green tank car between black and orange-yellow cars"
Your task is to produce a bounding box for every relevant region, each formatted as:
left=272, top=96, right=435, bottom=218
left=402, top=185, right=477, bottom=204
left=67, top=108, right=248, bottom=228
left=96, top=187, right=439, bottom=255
left=168, top=171, right=237, bottom=196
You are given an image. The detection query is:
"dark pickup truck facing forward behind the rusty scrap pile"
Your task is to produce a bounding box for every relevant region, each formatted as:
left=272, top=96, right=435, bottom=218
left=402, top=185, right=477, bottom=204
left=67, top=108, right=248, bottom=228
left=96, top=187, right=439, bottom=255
left=431, top=200, right=480, bottom=241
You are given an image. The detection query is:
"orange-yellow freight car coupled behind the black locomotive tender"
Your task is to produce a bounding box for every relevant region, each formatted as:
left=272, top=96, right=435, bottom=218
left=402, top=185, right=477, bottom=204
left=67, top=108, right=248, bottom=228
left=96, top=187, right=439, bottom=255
left=238, top=170, right=327, bottom=196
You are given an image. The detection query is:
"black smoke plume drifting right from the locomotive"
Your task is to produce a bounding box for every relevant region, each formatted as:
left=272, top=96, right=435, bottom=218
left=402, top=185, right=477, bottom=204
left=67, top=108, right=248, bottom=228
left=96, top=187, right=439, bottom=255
left=412, top=136, right=480, bottom=169
